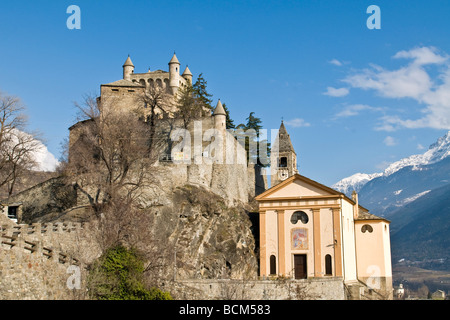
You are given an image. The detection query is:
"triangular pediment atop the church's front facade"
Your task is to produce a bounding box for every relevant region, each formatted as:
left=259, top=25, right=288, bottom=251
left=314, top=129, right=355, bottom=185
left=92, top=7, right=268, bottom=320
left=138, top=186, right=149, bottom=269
left=256, top=174, right=344, bottom=201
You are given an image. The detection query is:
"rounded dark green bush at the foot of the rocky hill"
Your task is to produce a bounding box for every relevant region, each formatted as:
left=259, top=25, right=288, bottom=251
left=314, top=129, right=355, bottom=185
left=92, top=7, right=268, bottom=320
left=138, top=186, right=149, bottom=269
left=88, top=246, right=172, bottom=300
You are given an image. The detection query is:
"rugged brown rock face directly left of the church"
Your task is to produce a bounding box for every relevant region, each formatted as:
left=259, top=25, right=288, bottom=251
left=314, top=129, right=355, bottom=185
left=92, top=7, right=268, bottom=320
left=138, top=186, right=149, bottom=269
left=154, top=185, right=258, bottom=279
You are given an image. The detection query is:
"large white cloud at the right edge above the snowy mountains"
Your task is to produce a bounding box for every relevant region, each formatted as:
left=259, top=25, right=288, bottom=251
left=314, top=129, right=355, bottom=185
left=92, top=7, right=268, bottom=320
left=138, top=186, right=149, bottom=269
left=343, top=47, right=450, bottom=131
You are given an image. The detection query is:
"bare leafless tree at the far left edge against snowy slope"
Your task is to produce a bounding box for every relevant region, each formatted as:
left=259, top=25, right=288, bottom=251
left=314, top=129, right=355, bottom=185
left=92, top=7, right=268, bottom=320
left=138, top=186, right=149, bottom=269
left=0, top=92, right=40, bottom=196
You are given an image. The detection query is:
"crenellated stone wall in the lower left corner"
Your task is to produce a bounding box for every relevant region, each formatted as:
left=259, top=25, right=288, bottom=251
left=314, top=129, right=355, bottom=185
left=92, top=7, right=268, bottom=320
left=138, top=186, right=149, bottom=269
left=0, top=221, right=100, bottom=300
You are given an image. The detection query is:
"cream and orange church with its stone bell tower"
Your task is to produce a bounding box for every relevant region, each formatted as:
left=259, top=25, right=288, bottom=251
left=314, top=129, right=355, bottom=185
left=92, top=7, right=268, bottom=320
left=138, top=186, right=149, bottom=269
left=262, top=123, right=392, bottom=299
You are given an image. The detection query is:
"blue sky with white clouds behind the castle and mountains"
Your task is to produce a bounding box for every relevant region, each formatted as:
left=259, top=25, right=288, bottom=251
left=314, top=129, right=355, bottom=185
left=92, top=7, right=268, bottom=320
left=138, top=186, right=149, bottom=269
left=0, top=0, right=450, bottom=185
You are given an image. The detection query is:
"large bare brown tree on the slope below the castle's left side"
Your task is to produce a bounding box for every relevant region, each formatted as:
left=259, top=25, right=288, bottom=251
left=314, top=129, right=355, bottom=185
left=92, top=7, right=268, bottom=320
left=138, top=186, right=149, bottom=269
left=66, top=96, right=155, bottom=217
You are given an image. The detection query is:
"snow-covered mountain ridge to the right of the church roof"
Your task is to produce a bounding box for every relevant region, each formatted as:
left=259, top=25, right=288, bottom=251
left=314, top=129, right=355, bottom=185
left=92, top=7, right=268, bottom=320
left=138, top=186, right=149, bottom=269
left=333, top=131, right=450, bottom=194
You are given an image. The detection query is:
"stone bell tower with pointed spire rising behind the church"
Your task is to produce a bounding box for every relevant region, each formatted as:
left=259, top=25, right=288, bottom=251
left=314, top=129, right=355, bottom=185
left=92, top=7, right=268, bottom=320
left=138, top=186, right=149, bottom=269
left=270, top=121, right=298, bottom=187
